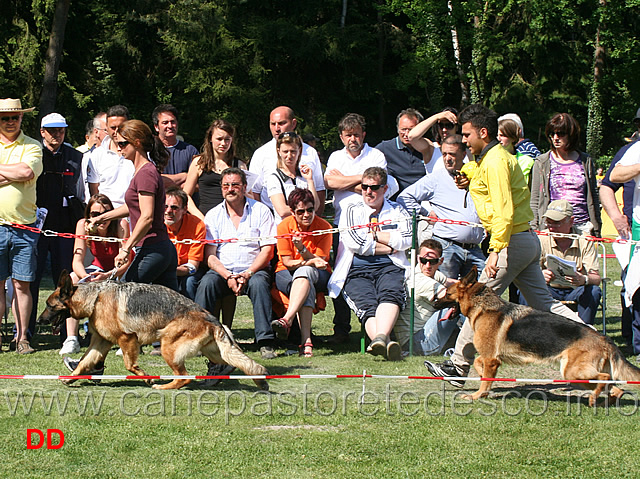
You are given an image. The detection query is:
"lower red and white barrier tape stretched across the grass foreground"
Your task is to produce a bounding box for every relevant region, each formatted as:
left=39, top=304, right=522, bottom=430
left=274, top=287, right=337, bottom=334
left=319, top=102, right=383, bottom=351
left=0, top=373, right=640, bottom=385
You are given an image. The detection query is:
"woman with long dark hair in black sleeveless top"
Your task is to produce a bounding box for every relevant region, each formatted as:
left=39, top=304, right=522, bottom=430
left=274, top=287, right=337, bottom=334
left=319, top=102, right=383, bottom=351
left=183, top=119, right=247, bottom=219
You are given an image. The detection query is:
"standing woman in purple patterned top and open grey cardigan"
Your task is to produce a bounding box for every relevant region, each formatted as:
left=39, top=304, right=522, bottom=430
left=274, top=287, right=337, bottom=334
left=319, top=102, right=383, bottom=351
left=531, top=113, right=602, bottom=236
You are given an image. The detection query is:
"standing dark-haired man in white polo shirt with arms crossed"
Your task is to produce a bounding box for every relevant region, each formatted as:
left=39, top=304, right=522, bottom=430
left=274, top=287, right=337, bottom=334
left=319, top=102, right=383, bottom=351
left=324, top=113, right=390, bottom=344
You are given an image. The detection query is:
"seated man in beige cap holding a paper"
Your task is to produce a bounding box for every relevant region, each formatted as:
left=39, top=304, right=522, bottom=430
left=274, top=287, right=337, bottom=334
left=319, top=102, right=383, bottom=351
left=520, top=200, right=602, bottom=324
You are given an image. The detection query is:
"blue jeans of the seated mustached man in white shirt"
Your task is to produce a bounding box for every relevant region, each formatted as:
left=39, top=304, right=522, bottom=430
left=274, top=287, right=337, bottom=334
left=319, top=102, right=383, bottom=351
left=196, top=270, right=276, bottom=344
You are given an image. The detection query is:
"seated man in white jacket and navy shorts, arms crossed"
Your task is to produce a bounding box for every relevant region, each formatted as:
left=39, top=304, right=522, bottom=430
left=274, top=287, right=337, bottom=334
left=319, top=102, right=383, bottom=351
left=329, top=166, right=411, bottom=361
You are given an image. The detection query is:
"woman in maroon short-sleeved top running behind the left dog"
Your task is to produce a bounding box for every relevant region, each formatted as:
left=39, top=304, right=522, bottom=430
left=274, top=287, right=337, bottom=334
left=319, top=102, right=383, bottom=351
left=86, top=120, right=178, bottom=291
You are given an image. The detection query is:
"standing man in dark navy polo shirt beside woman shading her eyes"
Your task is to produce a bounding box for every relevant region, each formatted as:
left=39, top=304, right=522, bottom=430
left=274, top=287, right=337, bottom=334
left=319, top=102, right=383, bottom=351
left=376, top=108, right=425, bottom=200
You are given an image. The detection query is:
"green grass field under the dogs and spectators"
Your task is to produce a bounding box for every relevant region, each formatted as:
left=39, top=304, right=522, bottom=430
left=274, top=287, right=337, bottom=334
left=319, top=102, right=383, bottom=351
left=0, top=249, right=640, bottom=478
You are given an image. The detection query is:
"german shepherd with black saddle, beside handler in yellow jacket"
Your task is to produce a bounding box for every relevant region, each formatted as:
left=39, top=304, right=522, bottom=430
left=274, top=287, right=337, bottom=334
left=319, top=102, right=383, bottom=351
left=439, top=266, right=640, bottom=406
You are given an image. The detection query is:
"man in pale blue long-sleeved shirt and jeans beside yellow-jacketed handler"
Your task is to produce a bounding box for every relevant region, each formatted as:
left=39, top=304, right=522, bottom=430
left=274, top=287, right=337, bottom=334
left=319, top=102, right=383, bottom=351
left=398, top=135, right=485, bottom=279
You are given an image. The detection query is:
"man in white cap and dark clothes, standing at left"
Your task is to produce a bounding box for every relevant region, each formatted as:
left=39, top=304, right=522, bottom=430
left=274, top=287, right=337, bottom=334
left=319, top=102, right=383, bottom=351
left=29, top=113, right=84, bottom=354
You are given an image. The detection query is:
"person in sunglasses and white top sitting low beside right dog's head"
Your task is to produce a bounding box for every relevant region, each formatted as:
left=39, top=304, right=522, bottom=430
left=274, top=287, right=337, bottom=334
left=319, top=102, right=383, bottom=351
left=394, top=239, right=458, bottom=356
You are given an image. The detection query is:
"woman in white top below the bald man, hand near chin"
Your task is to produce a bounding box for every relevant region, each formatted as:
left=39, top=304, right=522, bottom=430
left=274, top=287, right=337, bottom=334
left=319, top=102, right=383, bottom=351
left=266, top=131, right=320, bottom=224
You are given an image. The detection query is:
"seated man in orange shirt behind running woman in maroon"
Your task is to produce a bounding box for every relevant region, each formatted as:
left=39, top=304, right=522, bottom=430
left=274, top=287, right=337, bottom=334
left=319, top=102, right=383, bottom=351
left=164, top=186, right=207, bottom=299
